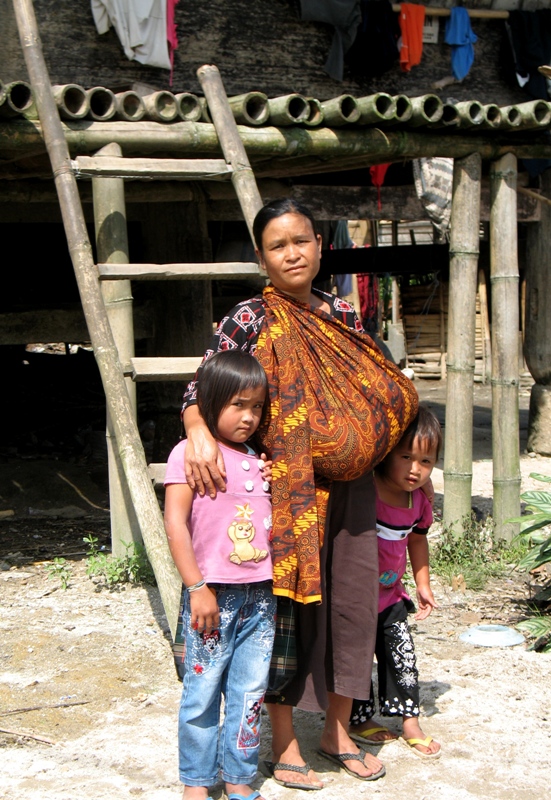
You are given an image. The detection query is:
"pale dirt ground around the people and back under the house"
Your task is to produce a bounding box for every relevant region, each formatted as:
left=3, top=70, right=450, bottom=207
left=0, top=381, right=551, bottom=800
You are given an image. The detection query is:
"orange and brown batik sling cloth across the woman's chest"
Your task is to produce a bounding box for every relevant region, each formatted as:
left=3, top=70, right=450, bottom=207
left=255, top=286, right=418, bottom=603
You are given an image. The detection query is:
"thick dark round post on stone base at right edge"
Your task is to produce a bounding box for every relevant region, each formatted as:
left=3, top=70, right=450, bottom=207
left=524, top=169, right=551, bottom=456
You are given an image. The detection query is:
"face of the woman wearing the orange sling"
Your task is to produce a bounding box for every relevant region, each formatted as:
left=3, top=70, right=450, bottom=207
left=257, top=214, right=321, bottom=299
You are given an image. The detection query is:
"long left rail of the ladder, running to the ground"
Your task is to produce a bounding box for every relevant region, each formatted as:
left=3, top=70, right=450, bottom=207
left=13, top=0, right=181, bottom=635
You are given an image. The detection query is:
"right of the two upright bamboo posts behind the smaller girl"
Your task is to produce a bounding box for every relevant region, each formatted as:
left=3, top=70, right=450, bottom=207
left=490, top=153, right=520, bottom=540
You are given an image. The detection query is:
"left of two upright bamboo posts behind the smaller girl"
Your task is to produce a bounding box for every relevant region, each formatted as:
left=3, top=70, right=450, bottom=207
left=444, top=153, right=482, bottom=530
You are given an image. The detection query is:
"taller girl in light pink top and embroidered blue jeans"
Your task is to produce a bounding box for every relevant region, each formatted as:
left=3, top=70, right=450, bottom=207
left=165, top=350, right=276, bottom=800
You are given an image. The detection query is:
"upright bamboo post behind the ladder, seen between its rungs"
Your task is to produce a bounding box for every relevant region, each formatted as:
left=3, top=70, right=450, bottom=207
left=92, top=144, right=142, bottom=556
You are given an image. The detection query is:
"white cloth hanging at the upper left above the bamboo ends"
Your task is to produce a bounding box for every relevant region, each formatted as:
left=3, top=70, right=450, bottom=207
left=91, top=0, right=171, bottom=69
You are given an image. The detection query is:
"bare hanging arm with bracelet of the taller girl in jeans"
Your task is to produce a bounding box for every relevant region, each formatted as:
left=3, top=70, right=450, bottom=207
left=165, top=482, right=220, bottom=631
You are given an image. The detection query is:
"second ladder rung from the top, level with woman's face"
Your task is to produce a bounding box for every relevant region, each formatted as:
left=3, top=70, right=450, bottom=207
left=98, top=261, right=262, bottom=281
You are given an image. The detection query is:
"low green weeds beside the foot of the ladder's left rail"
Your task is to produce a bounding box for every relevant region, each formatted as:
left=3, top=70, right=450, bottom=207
left=83, top=534, right=155, bottom=588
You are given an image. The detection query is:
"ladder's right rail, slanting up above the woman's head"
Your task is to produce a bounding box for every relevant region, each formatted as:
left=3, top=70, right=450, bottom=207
left=197, top=64, right=263, bottom=242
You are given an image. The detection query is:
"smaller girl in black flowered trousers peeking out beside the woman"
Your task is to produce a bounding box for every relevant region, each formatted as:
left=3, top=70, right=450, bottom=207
left=349, top=406, right=442, bottom=759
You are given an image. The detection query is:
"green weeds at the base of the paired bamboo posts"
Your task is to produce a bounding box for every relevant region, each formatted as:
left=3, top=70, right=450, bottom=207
left=430, top=514, right=523, bottom=590
